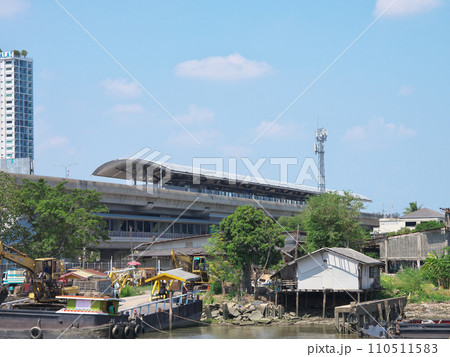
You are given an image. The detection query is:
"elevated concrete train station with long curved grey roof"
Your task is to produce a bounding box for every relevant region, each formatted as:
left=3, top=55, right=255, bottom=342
left=12, top=159, right=379, bottom=260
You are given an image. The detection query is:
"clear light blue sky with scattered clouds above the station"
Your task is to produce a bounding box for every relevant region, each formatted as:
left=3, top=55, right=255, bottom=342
left=0, top=0, right=450, bottom=213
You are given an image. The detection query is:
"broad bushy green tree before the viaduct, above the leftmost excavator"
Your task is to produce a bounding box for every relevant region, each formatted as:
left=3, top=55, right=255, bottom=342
left=15, top=179, right=109, bottom=259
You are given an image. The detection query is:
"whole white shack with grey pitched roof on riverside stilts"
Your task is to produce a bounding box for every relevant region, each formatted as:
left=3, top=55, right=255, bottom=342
left=272, top=248, right=382, bottom=316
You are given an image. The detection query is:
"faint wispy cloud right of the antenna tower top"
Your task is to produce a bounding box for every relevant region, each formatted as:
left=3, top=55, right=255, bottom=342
left=344, top=118, right=417, bottom=148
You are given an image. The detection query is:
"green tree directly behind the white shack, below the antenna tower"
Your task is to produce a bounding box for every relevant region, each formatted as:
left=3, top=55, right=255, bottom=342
left=303, top=192, right=365, bottom=252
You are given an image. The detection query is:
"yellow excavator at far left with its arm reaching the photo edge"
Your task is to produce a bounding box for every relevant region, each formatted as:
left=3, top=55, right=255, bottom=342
left=0, top=241, right=76, bottom=303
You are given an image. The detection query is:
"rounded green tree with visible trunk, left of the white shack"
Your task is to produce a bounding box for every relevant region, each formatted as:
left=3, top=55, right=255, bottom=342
left=219, top=206, right=285, bottom=293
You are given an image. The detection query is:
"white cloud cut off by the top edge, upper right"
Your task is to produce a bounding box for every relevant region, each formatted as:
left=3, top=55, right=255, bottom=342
left=375, top=0, right=443, bottom=17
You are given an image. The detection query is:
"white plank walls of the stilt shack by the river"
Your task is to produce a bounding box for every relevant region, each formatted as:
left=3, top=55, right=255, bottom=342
left=297, top=252, right=360, bottom=290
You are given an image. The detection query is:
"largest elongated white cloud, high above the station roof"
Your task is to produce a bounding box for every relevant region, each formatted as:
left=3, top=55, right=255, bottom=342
left=175, top=53, right=272, bottom=81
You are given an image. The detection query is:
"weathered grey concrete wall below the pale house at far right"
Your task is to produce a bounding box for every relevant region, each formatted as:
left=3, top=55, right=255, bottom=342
left=380, top=228, right=450, bottom=261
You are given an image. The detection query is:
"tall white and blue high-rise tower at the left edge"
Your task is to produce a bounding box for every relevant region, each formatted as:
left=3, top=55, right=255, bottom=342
left=0, top=51, right=34, bottom=162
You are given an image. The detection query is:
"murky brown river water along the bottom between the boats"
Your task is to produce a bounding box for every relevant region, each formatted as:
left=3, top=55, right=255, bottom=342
left=142, top=325, right=356, bottom=339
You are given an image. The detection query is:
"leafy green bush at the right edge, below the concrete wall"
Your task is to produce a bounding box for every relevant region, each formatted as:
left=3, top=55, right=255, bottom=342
left=420, top=247, right=450, bottom=289
